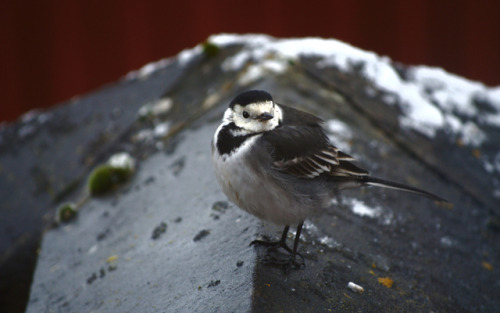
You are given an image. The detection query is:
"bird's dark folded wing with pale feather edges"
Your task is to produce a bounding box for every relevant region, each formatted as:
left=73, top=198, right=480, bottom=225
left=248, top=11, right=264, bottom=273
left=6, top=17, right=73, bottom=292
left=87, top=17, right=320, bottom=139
left=263, top=124, right=368, bottom=179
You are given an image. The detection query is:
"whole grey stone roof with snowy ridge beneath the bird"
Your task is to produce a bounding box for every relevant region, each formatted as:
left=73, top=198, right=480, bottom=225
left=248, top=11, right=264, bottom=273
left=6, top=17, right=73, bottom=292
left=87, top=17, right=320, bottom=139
left=0, top=35, right=500, bottom=312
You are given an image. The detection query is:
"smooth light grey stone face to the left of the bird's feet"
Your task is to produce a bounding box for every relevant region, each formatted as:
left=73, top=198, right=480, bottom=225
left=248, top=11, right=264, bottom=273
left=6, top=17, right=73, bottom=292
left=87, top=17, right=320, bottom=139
left=27, top=123, right=257, bottom=312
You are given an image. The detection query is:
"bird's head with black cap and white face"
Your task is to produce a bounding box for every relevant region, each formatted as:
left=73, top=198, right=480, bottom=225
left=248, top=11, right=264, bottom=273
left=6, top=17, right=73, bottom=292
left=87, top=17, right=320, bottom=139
left=224, top=90, right=282, bottom=135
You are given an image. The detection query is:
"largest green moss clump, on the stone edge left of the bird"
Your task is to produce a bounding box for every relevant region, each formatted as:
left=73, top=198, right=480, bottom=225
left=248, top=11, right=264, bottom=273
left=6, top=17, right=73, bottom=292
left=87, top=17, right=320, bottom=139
left=87, top=164, right=133, bottom=196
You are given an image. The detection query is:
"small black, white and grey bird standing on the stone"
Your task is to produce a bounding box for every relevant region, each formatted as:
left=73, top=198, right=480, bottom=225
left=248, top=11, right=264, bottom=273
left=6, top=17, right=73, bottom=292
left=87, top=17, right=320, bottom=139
left=211, top=90, right=447, bottom=268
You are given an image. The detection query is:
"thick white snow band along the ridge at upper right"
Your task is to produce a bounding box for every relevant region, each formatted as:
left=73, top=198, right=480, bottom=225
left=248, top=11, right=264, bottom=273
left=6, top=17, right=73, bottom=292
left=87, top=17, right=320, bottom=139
left=209, top=34, right=500, bottom=147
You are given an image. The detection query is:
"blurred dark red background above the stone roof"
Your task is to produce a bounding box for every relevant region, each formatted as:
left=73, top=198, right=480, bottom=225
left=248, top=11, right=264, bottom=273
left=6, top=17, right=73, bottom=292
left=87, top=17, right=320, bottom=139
left=0, top=0, right=500, bottom=122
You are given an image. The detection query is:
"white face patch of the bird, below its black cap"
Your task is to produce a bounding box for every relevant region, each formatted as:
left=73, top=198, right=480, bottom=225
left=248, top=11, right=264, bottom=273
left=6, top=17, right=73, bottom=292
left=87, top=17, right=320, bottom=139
left=228, top=101, right=283, bottom=136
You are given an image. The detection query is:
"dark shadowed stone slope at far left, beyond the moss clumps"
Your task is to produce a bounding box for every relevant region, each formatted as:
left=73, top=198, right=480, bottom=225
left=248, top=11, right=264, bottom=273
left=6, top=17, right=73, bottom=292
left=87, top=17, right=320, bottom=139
left=0, top=47, right=196, bottom=312
